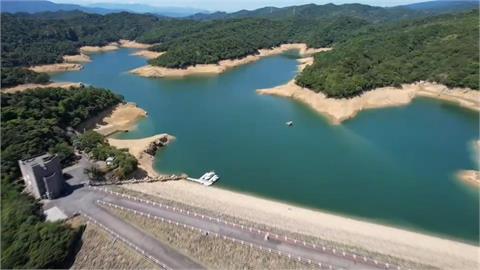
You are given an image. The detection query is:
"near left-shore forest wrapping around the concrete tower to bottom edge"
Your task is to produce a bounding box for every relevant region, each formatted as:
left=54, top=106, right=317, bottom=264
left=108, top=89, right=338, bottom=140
left=1, top=87, right=122, bottom=269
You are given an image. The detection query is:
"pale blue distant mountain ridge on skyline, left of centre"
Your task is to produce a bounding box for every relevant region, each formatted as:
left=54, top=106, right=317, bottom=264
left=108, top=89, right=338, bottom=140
left=89, top=3, right=208, bottom=17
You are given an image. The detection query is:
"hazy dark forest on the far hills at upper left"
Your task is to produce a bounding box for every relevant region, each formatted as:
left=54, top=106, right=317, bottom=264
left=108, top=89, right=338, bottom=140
left=1, top=12, right=158, bottom=67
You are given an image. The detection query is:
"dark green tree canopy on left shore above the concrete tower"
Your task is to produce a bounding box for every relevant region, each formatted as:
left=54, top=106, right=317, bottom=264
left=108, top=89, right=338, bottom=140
left=1, top=88, right=121, bottom=179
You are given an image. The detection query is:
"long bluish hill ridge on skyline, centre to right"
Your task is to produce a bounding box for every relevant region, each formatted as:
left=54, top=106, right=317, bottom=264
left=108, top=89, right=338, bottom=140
left=188, top=4, right=422, bottom=22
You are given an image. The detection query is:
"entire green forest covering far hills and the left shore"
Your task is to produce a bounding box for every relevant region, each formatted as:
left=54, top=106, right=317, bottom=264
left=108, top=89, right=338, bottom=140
left=0, top=5, right=479, bottom=268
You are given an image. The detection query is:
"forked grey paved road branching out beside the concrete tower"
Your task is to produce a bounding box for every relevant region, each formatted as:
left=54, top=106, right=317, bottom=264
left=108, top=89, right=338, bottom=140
left=46, top=161, right=385, bottom=269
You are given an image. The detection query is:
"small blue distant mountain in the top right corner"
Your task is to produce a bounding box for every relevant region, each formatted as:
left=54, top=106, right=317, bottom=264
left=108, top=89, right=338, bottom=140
left=403, top=0, right=480, bottom=14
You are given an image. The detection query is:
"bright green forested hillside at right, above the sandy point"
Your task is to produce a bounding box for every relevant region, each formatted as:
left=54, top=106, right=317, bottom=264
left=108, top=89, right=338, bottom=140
left=296, top=10, right=479, bottom=97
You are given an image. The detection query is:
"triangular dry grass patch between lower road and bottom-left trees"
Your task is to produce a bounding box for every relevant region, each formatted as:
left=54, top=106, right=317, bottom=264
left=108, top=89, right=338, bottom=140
left=69, top=217, right=158, bottom=269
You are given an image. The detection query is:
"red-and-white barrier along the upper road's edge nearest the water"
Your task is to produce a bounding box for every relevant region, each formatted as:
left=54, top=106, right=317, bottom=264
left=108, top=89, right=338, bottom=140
left=90, top=186, right=404, bottom=270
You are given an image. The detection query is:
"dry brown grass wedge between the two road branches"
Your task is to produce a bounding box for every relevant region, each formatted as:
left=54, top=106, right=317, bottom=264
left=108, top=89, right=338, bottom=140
left=109, top=208, right=312, bottom=269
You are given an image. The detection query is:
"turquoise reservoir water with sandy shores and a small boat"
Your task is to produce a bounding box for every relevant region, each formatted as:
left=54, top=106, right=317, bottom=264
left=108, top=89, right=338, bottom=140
left=53, top=49, right=479, bottom=243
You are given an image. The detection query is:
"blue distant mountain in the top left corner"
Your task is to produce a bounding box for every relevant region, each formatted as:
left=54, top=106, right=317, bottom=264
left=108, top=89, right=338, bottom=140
left=0, top=0, right=116, bottom=14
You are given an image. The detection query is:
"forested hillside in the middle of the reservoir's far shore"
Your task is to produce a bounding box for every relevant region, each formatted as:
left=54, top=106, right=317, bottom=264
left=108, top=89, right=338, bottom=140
left=139, top=17, right=370, bottom=68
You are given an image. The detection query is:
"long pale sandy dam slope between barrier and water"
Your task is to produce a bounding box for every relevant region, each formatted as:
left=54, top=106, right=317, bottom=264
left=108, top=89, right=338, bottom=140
left=128, top=181, right=480, bottom=269
